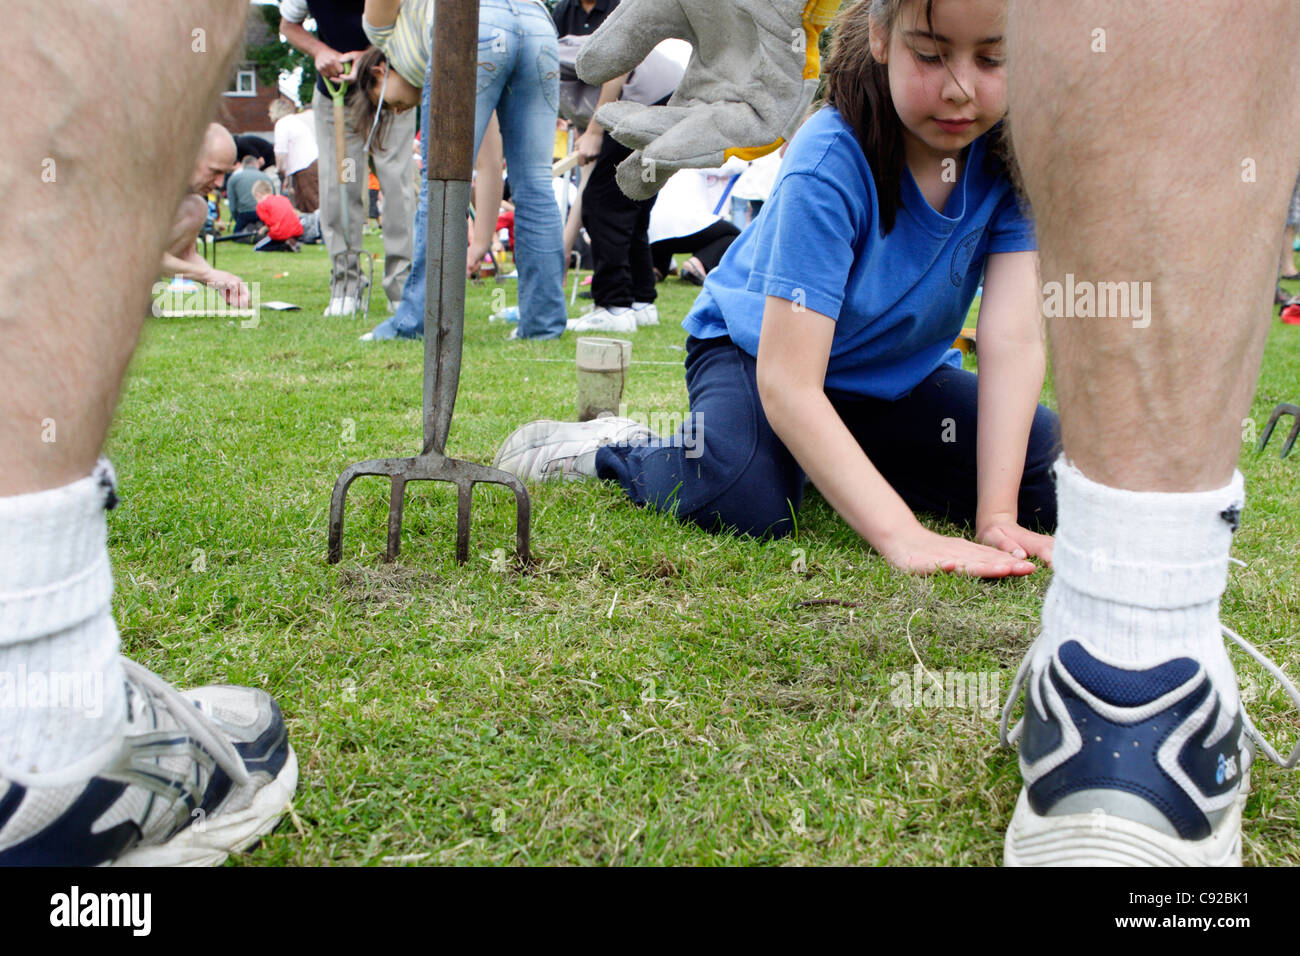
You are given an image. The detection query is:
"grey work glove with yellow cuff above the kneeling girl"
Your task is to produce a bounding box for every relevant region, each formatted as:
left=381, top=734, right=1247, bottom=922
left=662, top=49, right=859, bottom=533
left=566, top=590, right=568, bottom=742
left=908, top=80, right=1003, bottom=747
left=577, top=0, right=840, bottom=199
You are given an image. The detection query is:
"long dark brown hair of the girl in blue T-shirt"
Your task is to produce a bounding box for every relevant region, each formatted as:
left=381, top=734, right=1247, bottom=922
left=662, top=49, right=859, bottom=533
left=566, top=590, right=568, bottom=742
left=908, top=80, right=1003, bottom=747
left=822, top=0, right=1019, bottom=235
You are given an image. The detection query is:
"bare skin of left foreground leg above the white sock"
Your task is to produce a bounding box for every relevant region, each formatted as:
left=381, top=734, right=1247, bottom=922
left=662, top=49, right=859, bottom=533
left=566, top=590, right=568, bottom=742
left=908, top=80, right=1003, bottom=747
left=0, top=0, right=246, bottom=496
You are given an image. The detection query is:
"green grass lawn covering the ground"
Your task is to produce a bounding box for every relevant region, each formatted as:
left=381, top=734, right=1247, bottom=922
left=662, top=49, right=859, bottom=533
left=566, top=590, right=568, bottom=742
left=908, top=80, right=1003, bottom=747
left=108, top=237, right=1300, bottom=865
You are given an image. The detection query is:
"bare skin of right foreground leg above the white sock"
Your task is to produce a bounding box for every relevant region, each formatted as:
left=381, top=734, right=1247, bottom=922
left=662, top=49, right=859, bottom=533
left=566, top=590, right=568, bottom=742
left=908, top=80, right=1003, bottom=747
left=1008, top=0, right=1300, bottom=492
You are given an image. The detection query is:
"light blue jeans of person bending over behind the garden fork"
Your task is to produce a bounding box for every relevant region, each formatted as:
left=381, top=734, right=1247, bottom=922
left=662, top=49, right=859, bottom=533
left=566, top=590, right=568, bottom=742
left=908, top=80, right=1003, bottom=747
left=374, top=0, right=568, bottom=338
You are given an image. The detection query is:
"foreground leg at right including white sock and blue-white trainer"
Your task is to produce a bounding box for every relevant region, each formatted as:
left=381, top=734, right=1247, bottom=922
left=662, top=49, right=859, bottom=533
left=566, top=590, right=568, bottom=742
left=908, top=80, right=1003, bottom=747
left=1005, top=0, right=1300, bottom=865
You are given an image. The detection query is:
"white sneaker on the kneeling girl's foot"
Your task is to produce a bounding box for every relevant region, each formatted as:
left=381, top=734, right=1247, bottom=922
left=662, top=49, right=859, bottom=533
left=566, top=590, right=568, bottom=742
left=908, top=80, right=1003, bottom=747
left=493, top=416, right=658, bottom=481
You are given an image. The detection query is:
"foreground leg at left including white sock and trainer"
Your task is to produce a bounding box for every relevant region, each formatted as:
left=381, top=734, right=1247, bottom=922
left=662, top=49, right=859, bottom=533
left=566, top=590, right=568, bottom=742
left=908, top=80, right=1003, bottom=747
left=0, top=0, right=298, bottom=866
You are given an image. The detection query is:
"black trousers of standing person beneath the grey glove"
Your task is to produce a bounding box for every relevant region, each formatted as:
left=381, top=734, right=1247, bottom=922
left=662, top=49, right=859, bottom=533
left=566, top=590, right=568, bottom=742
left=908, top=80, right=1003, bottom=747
left=582, top=133, right=655, bottom=308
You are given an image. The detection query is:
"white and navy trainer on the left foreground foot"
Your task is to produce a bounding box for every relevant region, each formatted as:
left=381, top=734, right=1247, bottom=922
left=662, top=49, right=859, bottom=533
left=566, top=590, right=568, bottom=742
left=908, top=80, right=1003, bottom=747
left=0, top=659, right=298, bottom=866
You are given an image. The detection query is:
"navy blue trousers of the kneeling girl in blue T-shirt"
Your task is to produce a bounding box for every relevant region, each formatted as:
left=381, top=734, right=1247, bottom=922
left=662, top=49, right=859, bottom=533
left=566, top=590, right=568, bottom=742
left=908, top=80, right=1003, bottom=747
left=595, top=337, right=1061, bottom=537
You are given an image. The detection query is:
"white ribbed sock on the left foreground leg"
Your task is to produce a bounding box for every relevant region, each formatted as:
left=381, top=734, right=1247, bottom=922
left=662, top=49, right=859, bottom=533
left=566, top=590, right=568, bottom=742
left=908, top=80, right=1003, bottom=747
left=0, top=459, right=126, bottom=773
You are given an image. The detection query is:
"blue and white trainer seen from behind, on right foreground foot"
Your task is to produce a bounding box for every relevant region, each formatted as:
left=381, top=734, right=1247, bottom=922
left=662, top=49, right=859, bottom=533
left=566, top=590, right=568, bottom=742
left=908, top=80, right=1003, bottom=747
left=1001, top=628, right=1300, bottom=866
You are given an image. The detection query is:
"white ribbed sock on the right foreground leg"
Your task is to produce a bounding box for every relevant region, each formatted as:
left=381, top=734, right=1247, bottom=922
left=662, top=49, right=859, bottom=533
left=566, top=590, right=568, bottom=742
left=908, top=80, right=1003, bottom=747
left=1043, top=458, right=1245, bottom=696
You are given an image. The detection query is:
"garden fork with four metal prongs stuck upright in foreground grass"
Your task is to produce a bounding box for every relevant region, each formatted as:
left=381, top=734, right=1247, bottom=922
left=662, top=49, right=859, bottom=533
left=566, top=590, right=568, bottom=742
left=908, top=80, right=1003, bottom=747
left=329, top=0, right=529, bottom=567
